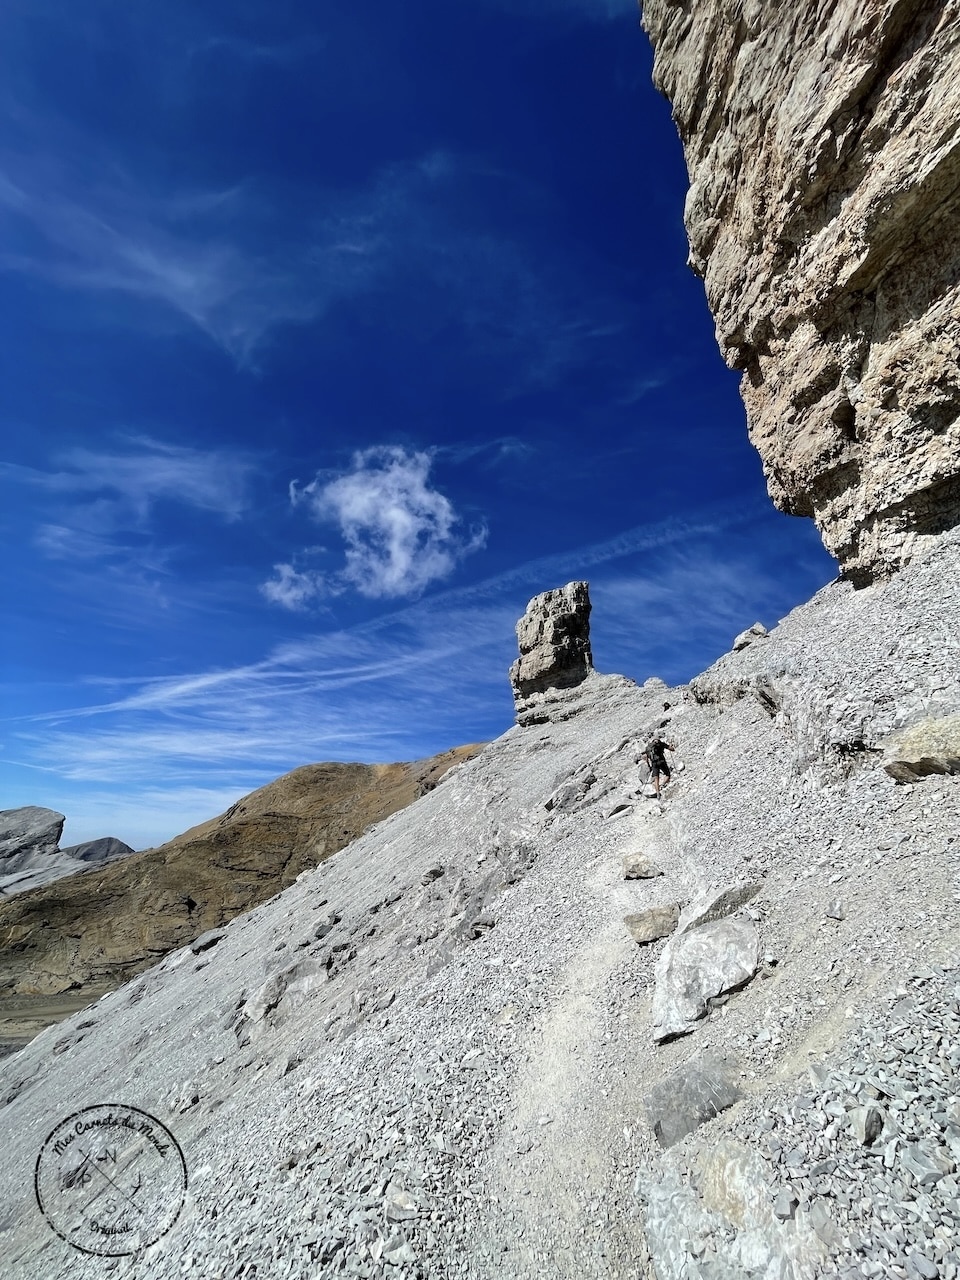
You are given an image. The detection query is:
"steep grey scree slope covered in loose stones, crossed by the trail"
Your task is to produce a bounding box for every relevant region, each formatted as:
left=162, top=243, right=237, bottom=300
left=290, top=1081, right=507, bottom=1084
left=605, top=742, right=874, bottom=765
left=0, top=535, right=960, bottom=1280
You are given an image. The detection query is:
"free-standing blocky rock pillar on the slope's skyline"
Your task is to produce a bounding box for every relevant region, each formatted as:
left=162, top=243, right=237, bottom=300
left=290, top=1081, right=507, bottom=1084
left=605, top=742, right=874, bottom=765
left=509, top=582, right=593, bottom=724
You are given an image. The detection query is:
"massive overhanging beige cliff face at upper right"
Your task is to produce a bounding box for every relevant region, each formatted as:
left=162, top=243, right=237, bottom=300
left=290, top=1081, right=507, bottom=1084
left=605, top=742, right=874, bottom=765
left=643, top=0, right=960, bottom=581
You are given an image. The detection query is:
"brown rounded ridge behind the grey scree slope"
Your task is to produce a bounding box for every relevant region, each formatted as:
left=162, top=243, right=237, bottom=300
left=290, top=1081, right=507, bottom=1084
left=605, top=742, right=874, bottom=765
left=0, top=744, right=483, bottom=1053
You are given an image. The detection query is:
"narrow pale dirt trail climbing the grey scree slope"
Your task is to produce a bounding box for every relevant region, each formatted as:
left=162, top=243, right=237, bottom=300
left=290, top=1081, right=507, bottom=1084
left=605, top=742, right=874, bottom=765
left=478, top=812, right=663, bottom=1280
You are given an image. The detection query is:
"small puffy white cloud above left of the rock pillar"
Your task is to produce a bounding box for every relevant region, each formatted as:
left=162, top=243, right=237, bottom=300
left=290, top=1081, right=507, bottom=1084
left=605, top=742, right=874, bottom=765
left=277, top=445, right=486, bottom=608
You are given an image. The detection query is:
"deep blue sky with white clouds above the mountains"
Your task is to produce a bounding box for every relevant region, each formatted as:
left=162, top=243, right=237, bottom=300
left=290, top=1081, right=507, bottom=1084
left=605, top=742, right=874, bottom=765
left=0, top=0, right=835, bottom=847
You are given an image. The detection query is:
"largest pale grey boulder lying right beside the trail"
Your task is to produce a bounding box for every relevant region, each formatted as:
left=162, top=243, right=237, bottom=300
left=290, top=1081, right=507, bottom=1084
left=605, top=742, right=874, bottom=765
left=653, top=918, right=760, bottom=1043
